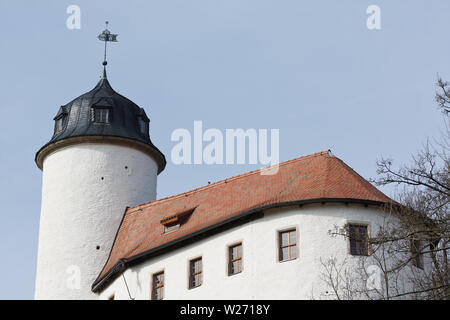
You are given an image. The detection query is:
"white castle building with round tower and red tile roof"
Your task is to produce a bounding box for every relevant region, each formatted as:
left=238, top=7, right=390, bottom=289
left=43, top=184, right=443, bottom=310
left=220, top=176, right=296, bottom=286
left=35, top=67, right=422, bottom=299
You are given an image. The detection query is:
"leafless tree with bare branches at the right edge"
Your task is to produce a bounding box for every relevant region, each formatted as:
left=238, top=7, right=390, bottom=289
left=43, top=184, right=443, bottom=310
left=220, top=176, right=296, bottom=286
left=321, top=79, right=450, bottom=300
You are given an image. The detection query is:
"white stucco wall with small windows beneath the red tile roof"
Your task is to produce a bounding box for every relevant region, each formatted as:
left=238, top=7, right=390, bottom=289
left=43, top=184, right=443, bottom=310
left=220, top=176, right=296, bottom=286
left=100, top=204, right=422, bottom=299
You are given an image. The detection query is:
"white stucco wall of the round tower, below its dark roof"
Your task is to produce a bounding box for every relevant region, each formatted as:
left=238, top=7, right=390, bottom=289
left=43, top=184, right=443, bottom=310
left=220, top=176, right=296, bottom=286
left=35, top=143, right=157, bottom=299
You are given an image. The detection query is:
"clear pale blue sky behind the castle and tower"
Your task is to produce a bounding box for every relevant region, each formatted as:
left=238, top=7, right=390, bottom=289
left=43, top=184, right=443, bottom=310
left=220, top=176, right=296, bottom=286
left=0, top=0, right=450, bottom=299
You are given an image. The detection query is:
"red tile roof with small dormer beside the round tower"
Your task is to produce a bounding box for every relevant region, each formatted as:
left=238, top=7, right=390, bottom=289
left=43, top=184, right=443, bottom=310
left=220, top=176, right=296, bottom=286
left=93, top=151, right=392, bottom=290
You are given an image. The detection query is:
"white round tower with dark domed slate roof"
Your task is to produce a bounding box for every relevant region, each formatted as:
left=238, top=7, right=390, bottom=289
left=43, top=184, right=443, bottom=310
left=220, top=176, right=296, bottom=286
left=35, top=71, right=166, bottom=299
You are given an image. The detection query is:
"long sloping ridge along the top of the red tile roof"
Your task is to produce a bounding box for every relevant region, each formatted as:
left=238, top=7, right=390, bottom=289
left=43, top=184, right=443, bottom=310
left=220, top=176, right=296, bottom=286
left=128, top=149, right=336, bottom=213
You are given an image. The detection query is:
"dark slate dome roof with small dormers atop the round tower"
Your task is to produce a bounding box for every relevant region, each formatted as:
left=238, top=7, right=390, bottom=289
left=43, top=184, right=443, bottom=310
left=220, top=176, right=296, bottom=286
left=36, top=70, right=166, bottom=173
